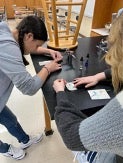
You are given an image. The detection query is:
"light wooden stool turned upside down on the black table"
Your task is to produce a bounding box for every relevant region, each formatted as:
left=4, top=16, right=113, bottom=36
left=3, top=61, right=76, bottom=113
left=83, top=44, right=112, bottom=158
left=42, top=0, right=87, bottom=50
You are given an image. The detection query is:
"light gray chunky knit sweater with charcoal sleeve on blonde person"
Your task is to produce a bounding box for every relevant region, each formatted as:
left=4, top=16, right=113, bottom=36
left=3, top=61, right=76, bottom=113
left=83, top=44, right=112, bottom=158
left=55, top=91, right=123, bottom=156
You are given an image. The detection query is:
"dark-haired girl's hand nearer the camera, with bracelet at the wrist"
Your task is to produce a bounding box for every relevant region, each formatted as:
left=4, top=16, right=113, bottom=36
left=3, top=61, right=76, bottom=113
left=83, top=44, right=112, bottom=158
left=44, top=60, right=62, bottom=74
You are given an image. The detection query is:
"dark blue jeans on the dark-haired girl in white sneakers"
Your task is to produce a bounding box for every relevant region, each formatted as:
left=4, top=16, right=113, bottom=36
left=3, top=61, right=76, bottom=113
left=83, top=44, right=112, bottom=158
left=0, top=106, right=29, bottom=153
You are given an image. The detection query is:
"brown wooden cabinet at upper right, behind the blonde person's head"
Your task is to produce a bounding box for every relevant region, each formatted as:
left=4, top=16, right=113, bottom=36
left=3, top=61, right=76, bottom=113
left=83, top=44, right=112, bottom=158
left=91, top=0, right=123, bottom=36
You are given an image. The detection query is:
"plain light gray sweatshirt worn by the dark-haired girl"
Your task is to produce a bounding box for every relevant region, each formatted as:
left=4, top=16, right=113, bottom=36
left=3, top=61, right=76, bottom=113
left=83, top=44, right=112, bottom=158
left=0, top=22, right=43, bottom=112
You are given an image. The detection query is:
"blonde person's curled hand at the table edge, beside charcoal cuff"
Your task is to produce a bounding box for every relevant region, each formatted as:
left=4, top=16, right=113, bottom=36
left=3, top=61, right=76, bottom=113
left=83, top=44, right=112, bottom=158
left=53, top=79, right=66, bottom=93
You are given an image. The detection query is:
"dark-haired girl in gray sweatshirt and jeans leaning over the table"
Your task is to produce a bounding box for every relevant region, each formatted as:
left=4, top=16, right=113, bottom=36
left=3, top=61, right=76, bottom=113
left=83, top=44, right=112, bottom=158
left=0, top=16, right=62, bottom=159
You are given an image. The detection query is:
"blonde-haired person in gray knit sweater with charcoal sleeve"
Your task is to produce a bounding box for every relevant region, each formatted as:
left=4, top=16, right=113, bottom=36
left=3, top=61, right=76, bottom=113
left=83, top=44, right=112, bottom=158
left=53, top=14, right=123, bottom=163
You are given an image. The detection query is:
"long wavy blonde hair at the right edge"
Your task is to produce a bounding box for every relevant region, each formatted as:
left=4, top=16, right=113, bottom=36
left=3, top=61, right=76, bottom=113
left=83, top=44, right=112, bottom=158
left=105, top=14, right=123, bottom=93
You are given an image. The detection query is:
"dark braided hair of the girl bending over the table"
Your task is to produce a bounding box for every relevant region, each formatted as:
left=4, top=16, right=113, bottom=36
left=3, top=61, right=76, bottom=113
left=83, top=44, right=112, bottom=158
left=16, top=16, right=47, bottom=65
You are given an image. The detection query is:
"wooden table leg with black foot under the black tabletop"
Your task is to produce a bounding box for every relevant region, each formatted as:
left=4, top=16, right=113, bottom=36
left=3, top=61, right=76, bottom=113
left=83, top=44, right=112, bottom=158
left=43, top=97, right=53, bottom=136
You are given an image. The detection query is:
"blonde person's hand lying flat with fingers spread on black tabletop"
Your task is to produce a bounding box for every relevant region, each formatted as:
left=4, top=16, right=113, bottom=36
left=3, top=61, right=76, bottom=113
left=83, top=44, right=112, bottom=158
left=73, top=75, right=99, bottom=88
